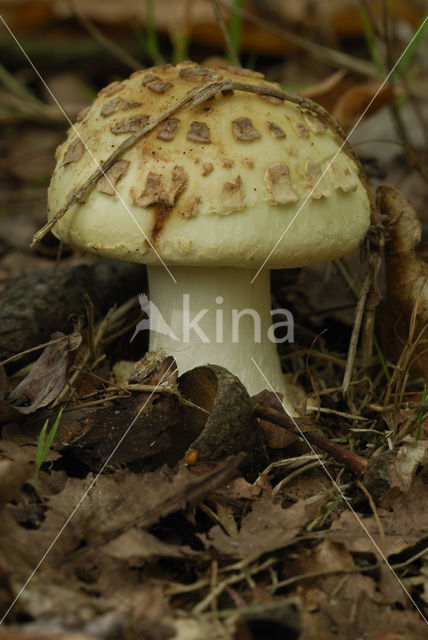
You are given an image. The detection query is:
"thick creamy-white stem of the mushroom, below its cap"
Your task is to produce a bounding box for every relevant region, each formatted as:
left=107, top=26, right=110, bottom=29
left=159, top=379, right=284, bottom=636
left=147, top=266, right=295, bottom=415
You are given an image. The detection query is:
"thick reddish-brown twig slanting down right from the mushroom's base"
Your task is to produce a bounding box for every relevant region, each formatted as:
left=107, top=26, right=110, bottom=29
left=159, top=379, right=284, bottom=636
left=254, top=404, right=367, bottom=475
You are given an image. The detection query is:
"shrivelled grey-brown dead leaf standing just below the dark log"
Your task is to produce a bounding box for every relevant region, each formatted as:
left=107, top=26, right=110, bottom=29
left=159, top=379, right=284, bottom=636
left=10, top=331, right=82, bottom=414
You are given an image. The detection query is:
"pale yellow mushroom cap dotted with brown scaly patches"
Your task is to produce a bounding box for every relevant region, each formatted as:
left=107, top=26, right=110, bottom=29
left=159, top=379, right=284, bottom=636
left=48, top=62, right=371, bottom=268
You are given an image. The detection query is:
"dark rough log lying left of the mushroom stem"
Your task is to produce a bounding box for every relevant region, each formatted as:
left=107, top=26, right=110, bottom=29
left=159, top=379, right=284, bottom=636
left=0, top=260, right=145, bottom=371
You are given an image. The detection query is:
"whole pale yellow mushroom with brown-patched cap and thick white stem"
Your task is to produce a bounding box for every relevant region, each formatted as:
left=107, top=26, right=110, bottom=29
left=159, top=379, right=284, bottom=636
left=49, top=62, right=371, bottom=413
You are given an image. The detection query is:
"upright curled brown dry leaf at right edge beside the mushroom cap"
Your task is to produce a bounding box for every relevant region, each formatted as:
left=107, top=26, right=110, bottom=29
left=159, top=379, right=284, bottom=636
left=377, top=186, right=428, bottom=379
